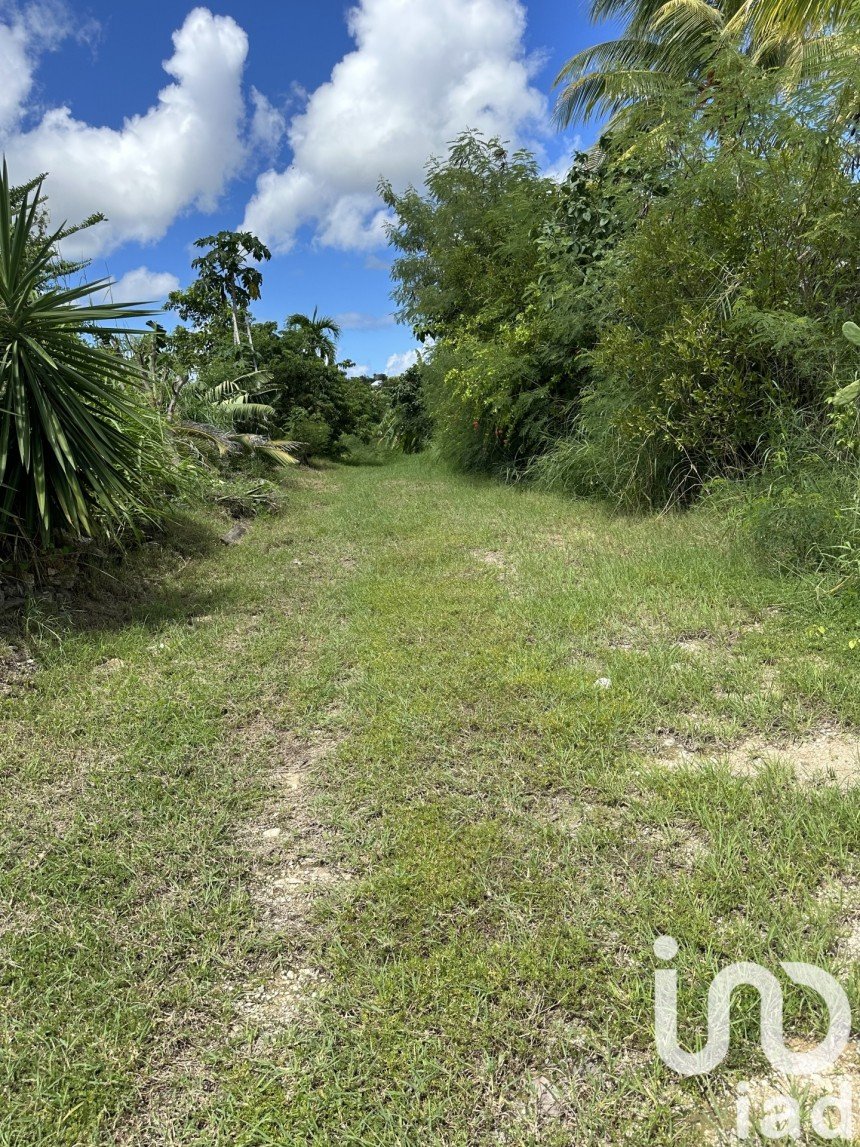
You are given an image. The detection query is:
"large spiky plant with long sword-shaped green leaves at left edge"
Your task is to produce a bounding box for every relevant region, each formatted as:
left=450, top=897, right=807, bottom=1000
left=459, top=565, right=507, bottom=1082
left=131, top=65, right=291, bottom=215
left=0, top=162, right=162, bottom=544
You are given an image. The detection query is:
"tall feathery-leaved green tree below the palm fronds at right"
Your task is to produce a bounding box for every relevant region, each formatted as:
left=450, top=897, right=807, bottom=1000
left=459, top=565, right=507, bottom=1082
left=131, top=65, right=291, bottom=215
left=571, top=69, right=860, bottom=504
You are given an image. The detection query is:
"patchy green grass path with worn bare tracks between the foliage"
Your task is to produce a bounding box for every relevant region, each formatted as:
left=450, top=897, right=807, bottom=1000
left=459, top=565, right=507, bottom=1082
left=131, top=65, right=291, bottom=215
left=0, top=460, right=860, bottom=1147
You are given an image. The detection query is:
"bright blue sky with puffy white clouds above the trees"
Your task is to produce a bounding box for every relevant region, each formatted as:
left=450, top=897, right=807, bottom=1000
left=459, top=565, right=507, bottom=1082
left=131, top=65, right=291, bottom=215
left=0, top=0, right=619, bottom=372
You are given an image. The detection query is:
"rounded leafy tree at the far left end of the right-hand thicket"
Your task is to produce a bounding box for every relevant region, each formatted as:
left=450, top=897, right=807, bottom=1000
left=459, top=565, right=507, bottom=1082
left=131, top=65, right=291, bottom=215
left=382, top=133, right=634, bottom=474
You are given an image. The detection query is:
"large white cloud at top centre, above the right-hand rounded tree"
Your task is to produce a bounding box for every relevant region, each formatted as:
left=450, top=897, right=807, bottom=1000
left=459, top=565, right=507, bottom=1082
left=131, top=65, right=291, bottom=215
left=243, top=0, right=547, bottom=250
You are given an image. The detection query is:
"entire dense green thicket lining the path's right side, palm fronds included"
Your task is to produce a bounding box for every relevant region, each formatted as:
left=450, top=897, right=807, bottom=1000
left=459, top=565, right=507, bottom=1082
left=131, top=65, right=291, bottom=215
left=382, top=17, right=860, bottom=573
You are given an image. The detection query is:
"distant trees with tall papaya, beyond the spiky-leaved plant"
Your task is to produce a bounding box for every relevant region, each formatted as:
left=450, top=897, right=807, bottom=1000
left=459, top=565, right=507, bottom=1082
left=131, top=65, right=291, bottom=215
left=163, top=233, right=380, bottom=461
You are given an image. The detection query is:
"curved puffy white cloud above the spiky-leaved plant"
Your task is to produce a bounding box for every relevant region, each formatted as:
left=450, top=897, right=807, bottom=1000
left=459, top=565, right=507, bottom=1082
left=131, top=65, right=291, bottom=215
left=0, top=8, right=248, bottom=256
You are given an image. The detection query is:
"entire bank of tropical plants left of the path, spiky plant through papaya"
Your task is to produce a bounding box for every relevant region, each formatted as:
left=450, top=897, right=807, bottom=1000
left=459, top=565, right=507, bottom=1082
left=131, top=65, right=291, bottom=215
left=0, top=167, right=384, bottom=554
